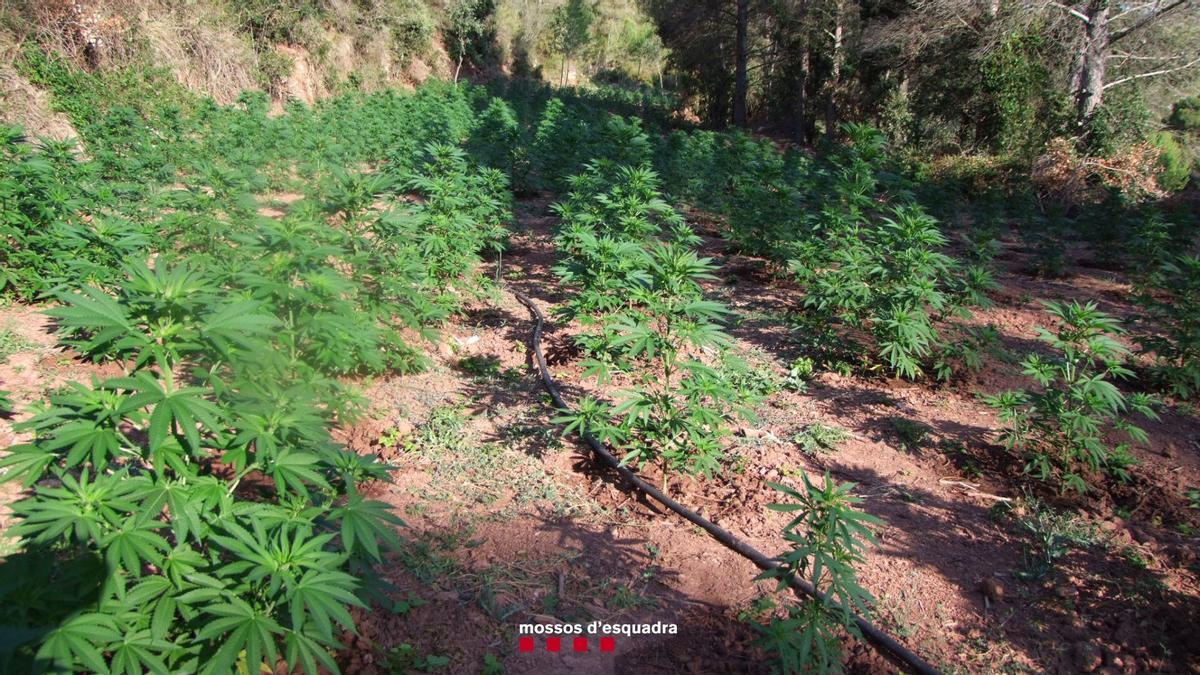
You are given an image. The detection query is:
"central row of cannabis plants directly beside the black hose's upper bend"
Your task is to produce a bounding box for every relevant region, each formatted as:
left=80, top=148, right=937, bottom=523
left=557, top=163, right=739, bottom=478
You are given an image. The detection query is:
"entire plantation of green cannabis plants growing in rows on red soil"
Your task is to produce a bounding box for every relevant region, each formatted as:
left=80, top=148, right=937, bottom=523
left=0, top=76, right=1200, bottom=673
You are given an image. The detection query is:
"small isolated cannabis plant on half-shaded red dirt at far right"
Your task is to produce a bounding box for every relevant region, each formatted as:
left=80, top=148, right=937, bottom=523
left=984, top=301, right=1157, bottom=492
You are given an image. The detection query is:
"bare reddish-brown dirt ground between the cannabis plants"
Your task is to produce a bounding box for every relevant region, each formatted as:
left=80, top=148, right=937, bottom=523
left=0, top=194, right=1200, bottom=674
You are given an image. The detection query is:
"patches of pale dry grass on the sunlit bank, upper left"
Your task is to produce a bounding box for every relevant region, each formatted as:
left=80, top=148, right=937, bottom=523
left=0, top=0, right=450, bottom=112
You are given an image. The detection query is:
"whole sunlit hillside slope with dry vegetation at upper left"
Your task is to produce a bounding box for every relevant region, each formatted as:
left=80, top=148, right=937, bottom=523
left=0, top=0, right=452, bottom=139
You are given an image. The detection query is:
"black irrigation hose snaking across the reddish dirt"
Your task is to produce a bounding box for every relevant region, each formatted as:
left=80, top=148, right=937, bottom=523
left=509, top=288, right=941, bottom=675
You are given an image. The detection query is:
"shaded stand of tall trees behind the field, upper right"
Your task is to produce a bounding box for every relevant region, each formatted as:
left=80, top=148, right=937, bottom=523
left=643, top=0, right=1200, bottom=148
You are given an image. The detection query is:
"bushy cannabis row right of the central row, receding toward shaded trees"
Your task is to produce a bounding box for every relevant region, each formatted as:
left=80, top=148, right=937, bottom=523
left=666, top=120, right=995, bottom=378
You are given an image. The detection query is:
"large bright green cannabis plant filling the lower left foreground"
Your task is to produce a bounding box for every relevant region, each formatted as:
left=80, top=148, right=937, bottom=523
left=0, top=261, right=398, bottom=673
